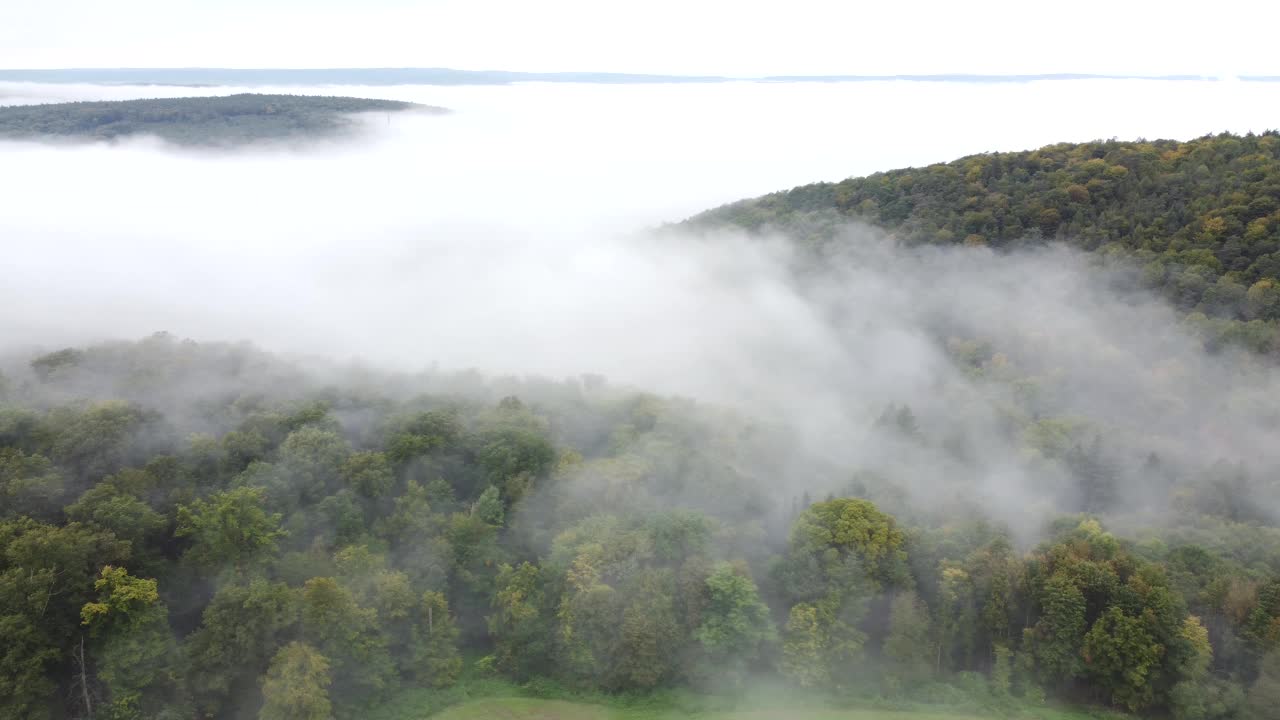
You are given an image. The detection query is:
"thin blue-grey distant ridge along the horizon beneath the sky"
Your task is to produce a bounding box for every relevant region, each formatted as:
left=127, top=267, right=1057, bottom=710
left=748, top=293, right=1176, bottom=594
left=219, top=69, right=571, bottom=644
left=0, top=68, right=1259, bottom=87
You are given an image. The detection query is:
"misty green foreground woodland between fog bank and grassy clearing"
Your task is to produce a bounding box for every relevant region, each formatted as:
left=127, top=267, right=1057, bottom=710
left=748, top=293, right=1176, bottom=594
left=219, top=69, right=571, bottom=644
left=0, top=326, right=1280, bottom=720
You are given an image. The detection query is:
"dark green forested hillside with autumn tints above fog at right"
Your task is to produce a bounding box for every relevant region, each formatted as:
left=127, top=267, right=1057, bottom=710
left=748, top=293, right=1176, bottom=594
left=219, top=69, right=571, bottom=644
left=689, top=131, right=1280, bottom=352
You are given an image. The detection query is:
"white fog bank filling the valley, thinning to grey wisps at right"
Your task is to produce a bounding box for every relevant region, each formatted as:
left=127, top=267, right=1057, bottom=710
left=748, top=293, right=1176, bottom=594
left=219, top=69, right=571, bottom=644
left=0, top=81, right=1280, bottom=532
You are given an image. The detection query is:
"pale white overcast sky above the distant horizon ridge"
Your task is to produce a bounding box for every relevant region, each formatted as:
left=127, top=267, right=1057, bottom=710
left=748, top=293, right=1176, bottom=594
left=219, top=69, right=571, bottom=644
left=0, top=0, right=1280, bottom=76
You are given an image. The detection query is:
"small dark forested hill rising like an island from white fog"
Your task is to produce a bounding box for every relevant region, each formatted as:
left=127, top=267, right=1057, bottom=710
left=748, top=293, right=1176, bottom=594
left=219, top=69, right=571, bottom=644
left=0, top=94, right=444, bottom=146
